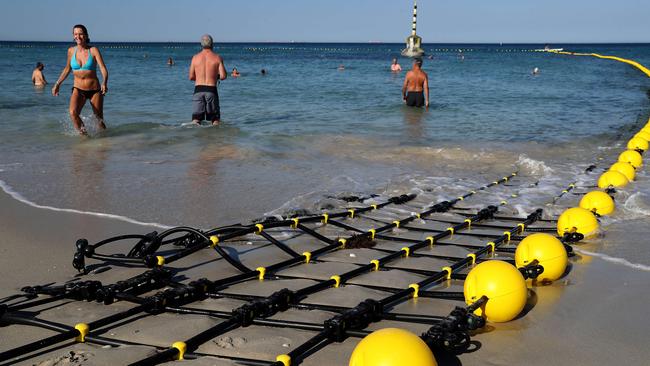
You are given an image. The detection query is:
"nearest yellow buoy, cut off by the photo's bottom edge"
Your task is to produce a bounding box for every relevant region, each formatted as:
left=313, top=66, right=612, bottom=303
left=349, top=328, right=438, bottom=366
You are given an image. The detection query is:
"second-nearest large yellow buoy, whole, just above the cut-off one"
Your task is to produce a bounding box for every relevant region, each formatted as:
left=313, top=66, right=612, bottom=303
left=463, top=260, right=528, bottom=323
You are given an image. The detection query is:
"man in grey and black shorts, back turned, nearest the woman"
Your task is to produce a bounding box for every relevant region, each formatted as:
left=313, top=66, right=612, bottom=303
left=190, top=34, right=228, bottom=126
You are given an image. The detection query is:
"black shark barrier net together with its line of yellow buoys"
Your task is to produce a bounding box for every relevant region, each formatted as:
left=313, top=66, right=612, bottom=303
left=0, top=53, right=650, bottom=366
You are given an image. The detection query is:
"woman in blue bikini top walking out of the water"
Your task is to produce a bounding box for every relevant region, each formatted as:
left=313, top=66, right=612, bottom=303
left=52, top=24, right=108, bottom=135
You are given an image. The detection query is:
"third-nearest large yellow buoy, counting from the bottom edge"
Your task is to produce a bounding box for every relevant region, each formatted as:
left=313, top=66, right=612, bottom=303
left=515, top=233, right=569, bottom=282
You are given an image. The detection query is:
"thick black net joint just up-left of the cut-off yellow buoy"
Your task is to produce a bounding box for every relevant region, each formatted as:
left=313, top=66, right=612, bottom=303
left=324, top=299, right=384, bottom=343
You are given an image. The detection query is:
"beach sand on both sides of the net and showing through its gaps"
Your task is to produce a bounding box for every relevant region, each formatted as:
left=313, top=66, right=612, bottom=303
left=0, top=192, right=650, bottom=366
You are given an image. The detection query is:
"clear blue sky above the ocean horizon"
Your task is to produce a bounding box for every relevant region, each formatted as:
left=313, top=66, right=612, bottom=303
left=0, top=0, right=650, bottom=43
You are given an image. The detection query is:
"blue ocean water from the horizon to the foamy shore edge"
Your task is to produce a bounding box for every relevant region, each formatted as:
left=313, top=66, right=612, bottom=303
left=0, top=42, right=650, bottom=265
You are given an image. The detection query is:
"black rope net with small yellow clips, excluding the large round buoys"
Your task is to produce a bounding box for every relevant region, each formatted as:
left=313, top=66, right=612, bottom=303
left=0, top=166, right=604, bottom=365
